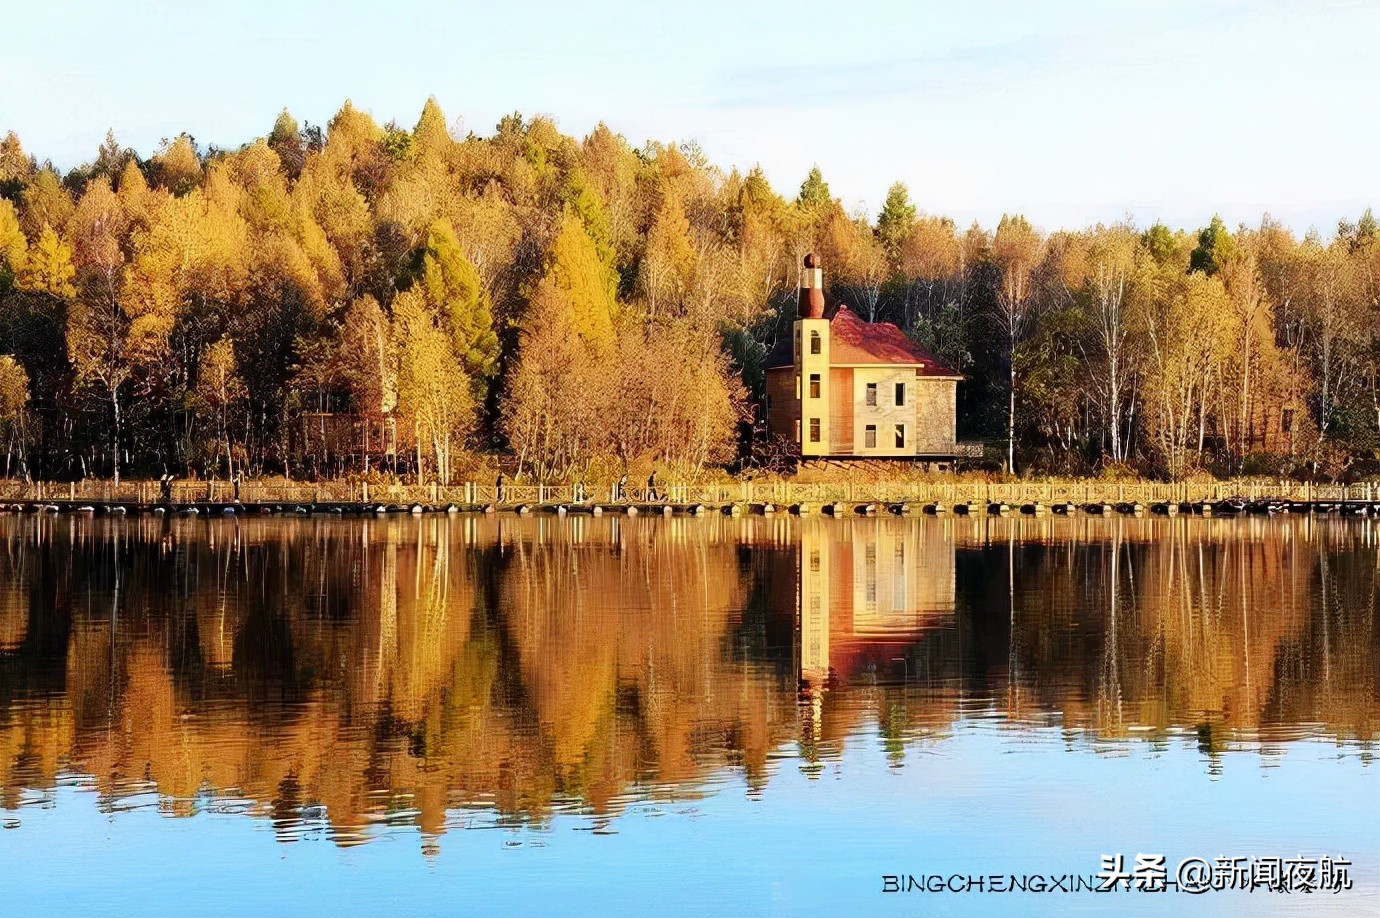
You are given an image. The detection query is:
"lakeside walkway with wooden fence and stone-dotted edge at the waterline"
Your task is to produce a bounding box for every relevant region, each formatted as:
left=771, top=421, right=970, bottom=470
left=0, top=479, right=1380, bottom=515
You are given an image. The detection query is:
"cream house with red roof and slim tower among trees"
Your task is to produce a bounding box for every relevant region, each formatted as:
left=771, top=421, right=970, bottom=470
left=766, top=254, right=962, bottom=468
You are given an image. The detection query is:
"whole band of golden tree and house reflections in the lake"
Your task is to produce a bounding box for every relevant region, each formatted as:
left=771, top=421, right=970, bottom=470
left=0, top=516, right=1380, bottom=852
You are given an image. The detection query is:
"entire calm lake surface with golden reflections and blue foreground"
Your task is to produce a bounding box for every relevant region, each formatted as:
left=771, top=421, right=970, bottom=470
left=0, top=516, right=1380, bottom=915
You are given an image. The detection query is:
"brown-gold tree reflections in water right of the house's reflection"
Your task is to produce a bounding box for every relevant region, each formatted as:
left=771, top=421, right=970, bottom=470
left=977, top=510, right=1380, bottom=739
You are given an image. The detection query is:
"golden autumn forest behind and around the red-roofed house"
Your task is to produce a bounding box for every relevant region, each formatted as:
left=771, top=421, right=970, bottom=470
left=0, top=99, right=1380, bottom=483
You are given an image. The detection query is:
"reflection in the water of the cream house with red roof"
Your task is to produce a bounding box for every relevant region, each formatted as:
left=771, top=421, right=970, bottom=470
left=798, top=518, right=955, bottom=683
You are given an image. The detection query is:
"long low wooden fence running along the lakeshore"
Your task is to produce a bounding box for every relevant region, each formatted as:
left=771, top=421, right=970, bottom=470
left=0, top=480, right=1380, bottom=507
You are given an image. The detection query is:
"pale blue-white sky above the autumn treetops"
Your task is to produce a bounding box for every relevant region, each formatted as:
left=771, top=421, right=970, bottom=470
left=0, top=0, right=1380, bottom=233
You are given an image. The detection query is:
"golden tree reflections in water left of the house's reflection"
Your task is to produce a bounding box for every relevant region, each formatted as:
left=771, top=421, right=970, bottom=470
left=0, top=518, right=789, bottom=842
